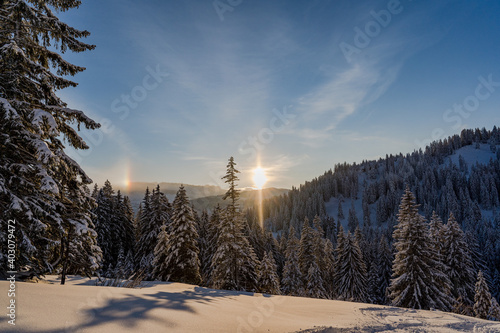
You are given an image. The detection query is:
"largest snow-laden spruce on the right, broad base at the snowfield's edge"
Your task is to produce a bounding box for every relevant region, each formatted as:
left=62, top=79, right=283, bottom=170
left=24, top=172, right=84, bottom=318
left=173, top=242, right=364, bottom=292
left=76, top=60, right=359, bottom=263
left=389, top=187, right=453, bottom=311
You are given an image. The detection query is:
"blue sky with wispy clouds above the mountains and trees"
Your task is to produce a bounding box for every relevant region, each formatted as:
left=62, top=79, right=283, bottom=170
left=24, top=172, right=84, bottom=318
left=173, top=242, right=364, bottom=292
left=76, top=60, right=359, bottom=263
left=56, top=0, right=500, bottom=188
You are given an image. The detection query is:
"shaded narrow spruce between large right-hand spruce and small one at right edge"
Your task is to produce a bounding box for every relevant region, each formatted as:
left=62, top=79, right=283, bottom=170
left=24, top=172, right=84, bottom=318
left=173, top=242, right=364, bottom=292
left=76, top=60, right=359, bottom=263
left=443, top=213, right=476, bottom=306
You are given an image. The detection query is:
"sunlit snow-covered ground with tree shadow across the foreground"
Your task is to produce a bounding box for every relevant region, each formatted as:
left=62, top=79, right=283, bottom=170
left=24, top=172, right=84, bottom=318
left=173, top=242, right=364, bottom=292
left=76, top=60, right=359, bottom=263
left=0, top=276, right=500, bottom=333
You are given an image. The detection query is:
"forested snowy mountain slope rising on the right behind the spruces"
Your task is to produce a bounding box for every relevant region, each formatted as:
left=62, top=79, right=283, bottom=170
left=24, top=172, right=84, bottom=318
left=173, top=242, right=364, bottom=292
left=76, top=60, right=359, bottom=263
left=264, top=127, right=500, bottom=235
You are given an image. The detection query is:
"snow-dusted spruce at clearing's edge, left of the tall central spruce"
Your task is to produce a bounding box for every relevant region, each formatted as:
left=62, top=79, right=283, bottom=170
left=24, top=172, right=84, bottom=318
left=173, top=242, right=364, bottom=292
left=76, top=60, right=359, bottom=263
left=165, top=185, right=201, bottom=284
